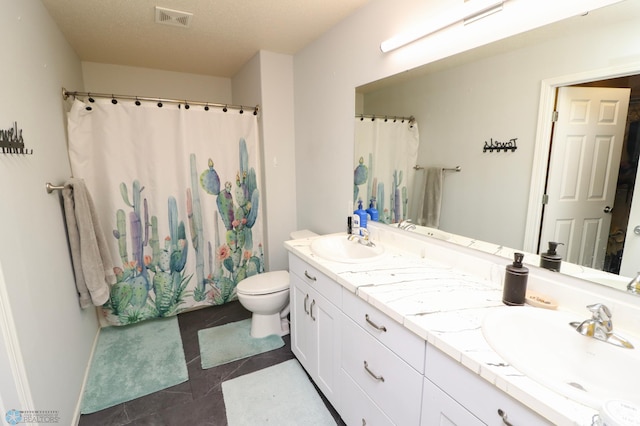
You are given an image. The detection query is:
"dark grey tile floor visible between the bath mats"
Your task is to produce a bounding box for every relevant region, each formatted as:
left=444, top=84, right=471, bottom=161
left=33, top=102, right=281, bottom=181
left=79, top=301, right=344, bottom=426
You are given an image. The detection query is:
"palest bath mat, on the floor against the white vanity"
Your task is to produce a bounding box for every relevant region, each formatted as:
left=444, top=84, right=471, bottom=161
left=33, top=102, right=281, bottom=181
left=222, top=359, right=336, bottom=426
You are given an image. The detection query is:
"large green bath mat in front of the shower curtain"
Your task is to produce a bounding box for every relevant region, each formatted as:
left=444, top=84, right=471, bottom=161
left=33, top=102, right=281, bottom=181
left=80, top=317, right=189, bottom=414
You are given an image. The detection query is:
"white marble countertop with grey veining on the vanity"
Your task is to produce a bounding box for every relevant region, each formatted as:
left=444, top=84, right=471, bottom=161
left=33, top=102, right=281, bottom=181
left=285, top=231, right=597, bottom=426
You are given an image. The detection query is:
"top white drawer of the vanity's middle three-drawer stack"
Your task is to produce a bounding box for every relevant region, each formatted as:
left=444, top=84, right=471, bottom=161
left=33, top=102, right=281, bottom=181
left=342, top=290, right=426, bottom=373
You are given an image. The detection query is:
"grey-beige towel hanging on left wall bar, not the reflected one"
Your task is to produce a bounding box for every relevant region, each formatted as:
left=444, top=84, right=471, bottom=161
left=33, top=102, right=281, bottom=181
left=62, top=178, right=116, bottom=308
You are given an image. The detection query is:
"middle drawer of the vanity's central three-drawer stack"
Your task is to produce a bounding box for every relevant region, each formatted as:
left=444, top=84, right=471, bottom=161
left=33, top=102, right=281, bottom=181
left=342, top=317, right=423, bottom=425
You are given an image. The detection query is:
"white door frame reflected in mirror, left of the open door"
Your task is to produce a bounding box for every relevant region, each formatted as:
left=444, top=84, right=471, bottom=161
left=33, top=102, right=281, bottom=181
left=523, top=62, right=640, bottom=253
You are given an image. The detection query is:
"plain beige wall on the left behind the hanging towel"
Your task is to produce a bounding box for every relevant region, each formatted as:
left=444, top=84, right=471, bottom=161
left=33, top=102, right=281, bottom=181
left=0, top=0, right=98, bottom=425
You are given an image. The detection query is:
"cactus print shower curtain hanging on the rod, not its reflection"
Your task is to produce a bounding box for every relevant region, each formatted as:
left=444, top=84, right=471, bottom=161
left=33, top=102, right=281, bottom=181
left=68, top=99, right=264, bottom=325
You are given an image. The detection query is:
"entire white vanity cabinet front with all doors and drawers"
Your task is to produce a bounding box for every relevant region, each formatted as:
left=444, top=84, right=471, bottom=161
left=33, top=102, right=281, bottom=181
left=289, top=254, right=551, bottom=426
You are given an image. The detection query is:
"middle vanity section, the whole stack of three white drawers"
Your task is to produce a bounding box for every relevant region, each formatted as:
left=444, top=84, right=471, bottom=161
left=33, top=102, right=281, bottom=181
left=341, top=290, right=425, bottom=425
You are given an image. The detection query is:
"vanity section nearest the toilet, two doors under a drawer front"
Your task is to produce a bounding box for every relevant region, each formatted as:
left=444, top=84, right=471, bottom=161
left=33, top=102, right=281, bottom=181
left=289, top=255, right=342, bottom=411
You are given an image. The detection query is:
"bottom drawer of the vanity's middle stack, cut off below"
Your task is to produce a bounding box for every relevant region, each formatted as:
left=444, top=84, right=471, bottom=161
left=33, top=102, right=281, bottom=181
left=340, top=370, right=394, bottom=426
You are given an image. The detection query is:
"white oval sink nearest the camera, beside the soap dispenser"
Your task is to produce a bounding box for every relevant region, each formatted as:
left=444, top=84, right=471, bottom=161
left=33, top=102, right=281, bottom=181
left=482, top=307, right=640, bottom=410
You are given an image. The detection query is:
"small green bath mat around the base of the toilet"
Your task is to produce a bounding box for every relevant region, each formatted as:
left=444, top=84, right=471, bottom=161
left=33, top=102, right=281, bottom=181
left=198, top=319, right=284, bottom=369
